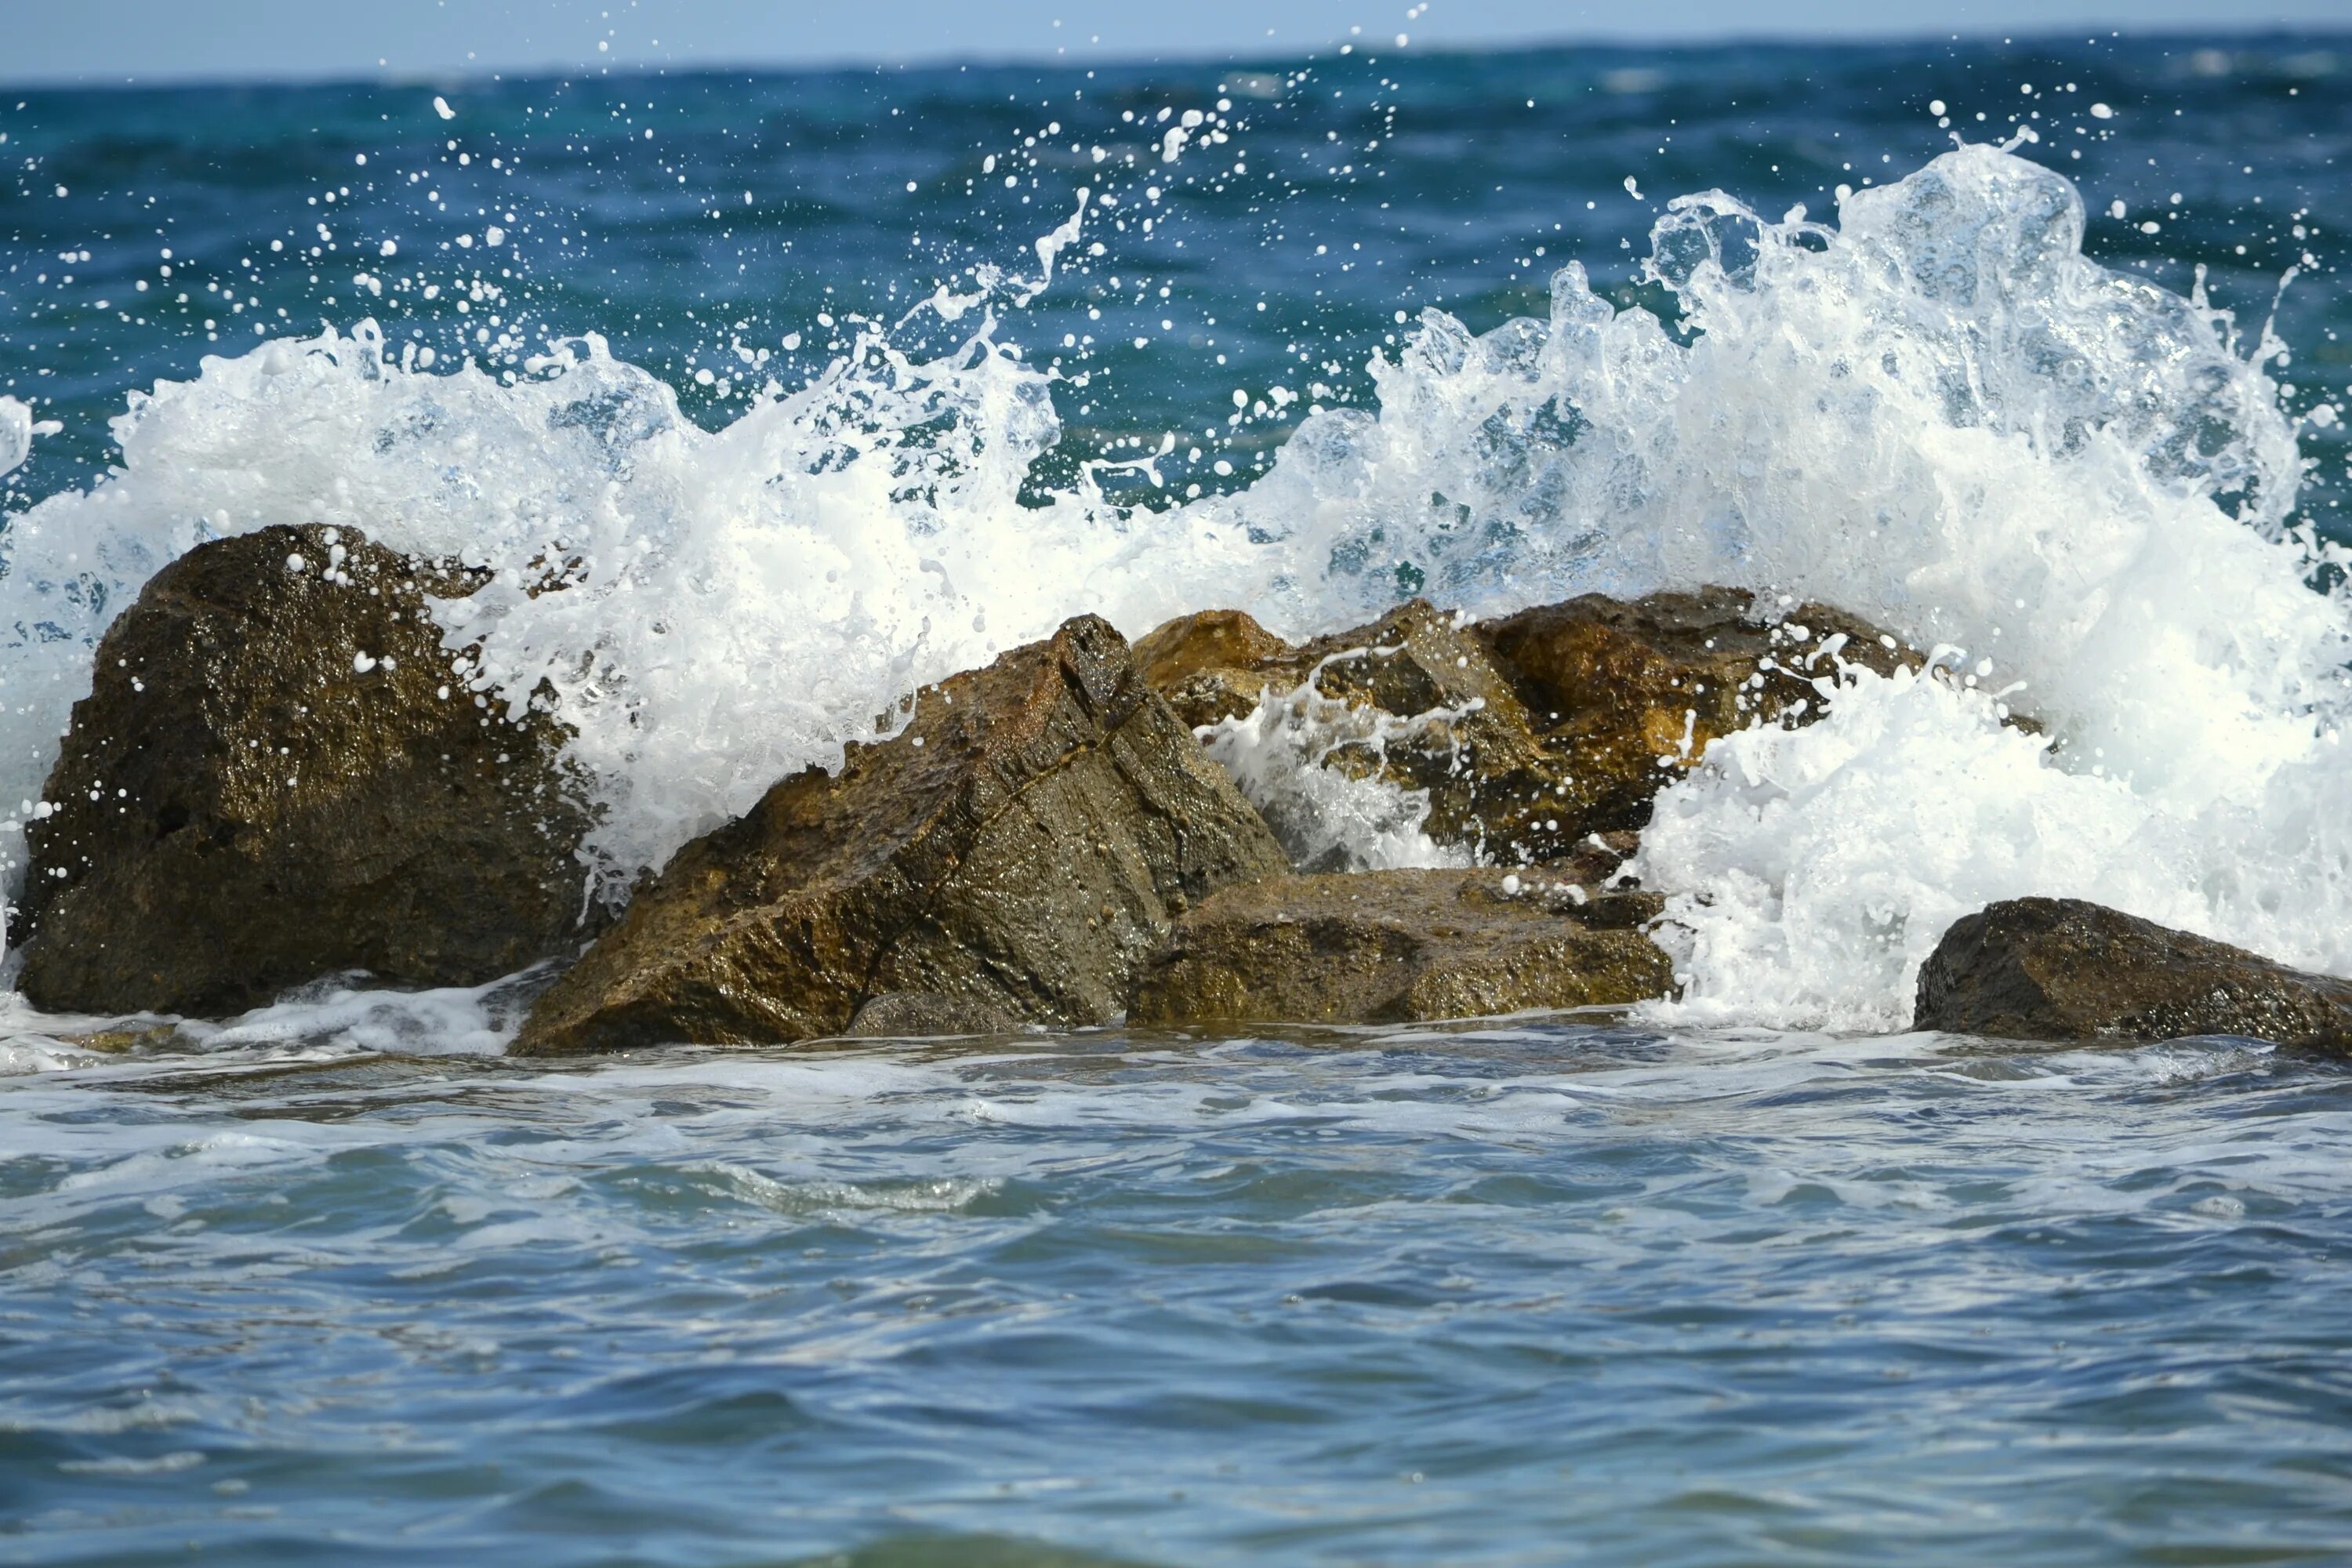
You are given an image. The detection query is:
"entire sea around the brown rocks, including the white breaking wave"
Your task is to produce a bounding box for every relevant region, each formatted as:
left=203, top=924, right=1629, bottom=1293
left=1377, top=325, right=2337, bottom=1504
left=0, top=35, right=2352, bottom=1568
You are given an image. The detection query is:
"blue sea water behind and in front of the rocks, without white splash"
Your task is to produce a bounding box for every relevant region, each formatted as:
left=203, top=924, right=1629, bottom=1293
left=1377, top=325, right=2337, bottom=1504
left=0, top=38, right=2352, bottom=1566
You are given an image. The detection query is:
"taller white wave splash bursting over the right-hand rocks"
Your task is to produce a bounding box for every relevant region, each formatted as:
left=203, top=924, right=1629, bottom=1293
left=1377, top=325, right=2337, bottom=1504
left=1200, top=148, right=2352, bottom=1029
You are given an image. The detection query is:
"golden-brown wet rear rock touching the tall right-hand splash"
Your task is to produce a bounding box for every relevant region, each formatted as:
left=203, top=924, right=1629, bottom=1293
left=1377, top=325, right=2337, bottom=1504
left=1475, top=588, right=1926, bottom=837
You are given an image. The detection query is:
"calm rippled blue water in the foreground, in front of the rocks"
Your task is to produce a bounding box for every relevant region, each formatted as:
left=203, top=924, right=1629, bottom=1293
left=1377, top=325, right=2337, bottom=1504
left=0, top=1022, right=2352, bottom=1563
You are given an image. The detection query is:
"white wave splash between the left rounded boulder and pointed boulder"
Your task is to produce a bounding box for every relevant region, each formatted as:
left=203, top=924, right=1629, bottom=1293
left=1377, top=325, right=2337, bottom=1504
left=0, top=305, right=1195, bottom=902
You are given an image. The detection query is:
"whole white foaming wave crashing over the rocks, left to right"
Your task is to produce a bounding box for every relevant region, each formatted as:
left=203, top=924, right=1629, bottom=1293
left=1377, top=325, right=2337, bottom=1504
left=0, top=146, right=2352, bottom=1027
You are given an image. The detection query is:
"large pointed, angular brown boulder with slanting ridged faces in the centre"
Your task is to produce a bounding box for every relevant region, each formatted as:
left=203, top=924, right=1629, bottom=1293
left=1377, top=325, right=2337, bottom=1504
left=513, top=616, right=1284, bottom=1055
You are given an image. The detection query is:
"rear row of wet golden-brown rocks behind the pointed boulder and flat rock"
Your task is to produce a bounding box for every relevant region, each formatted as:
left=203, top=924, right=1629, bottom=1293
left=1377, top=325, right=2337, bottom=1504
left=1136, top=588, right=1924, bottom=869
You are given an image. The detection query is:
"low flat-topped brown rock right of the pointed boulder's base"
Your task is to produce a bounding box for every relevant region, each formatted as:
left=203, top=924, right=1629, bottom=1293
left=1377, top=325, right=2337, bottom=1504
left=1129, top=869, right=1675, bottom=1022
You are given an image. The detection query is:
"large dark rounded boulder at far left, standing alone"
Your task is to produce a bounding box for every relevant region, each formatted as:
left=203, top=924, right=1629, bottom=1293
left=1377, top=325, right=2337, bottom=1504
left=12, top=527, right=590, bottom=1013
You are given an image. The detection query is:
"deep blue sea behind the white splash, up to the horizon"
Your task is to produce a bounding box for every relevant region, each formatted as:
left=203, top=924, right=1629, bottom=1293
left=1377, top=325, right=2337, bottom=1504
left=0, top=35, right=2352, bottom=527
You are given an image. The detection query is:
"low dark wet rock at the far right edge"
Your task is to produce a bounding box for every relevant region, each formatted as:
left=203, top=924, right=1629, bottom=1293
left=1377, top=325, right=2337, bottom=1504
left=1912, top=898, right=2352, bottom=1055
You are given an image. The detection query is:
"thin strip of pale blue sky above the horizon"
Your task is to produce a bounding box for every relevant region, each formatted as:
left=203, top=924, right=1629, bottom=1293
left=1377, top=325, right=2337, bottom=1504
left=0, top=0, right=2352, bottom=85
